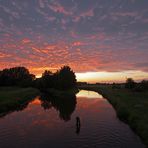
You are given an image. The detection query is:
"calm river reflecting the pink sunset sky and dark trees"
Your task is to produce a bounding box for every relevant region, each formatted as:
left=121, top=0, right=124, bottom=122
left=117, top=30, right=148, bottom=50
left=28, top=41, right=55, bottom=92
left=0, top=90, right=144, bottom=148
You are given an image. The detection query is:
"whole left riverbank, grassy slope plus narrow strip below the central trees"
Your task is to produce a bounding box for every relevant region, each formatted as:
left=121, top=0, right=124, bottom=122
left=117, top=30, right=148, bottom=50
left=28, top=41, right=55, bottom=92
left=0, top=87, right=79, bottom=117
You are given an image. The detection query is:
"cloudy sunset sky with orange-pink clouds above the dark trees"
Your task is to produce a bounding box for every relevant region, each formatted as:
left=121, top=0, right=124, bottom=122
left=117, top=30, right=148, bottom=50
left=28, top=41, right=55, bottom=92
left=0, top=0, right=148, bottom=83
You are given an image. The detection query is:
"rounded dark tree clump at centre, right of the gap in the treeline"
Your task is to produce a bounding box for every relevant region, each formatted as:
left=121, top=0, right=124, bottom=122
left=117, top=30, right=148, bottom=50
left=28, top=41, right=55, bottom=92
left=34, top=66, right=76, bottom=90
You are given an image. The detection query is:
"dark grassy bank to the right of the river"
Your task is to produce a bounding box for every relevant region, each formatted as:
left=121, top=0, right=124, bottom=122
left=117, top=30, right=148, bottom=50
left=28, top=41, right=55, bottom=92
left=80, top=85, right=148, bottom=147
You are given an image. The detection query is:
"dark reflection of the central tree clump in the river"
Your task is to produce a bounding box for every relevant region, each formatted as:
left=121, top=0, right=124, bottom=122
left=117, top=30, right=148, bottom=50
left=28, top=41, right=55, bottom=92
left=40, top=93, right=77, bottom=121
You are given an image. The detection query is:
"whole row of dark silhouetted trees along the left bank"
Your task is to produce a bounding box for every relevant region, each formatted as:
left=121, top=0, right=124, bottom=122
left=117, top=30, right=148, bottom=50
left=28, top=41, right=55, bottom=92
left=0, top=66, right=76, bottom=90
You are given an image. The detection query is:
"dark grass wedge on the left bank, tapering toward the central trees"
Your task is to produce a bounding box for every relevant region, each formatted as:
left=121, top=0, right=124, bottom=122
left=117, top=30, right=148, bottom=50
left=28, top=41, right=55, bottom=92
left=0, top=87, right=40, bottom=116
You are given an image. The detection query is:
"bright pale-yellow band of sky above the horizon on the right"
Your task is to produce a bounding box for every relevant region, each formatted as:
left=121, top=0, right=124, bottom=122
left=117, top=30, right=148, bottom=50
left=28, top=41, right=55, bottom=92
left=76, top=70, right=148, bottom=83
